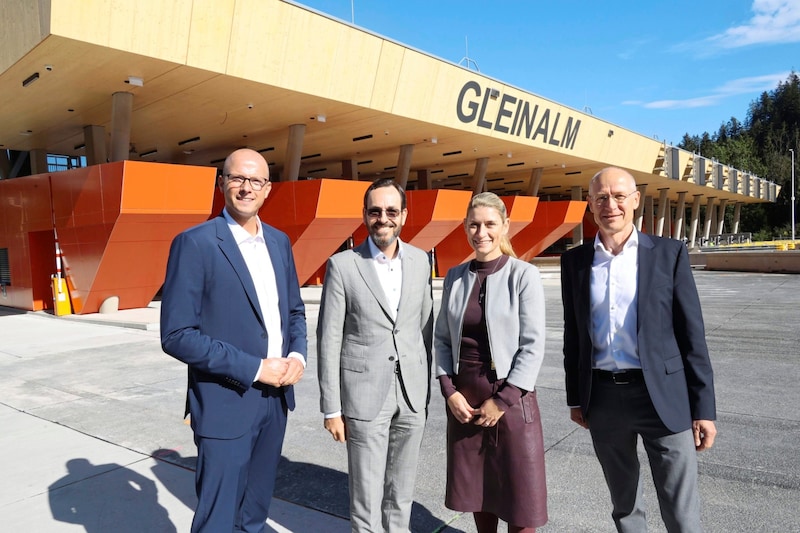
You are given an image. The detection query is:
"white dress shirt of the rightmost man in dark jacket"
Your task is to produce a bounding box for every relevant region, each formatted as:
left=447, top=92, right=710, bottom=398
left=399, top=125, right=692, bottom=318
left=590, top=228, right=642, bottom=371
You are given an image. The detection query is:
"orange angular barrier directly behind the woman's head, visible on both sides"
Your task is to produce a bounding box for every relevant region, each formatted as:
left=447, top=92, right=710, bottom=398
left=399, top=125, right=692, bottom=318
left=436, top=196, right=539, bottom=276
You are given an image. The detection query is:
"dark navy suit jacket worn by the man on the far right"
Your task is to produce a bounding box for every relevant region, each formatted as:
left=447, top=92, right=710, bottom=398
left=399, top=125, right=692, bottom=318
left=561, top=233, right=716, bottom=433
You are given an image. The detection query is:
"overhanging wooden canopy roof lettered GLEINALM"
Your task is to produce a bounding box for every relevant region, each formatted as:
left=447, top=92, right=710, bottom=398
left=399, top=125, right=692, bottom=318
left=0, top=0, right=777, bottom=202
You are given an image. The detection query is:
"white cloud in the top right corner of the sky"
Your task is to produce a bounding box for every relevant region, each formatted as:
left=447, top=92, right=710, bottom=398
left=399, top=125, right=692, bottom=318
left=705, top=0, right=800, bottom=49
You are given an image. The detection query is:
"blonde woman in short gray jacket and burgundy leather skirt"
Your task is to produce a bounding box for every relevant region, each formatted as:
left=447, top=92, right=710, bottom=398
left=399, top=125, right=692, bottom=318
left=434, top=193, right=547, bottom=533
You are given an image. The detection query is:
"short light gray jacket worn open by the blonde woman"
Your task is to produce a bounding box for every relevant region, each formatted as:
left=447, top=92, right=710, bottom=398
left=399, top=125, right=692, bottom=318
left=434, top=257, right=545, bottom=391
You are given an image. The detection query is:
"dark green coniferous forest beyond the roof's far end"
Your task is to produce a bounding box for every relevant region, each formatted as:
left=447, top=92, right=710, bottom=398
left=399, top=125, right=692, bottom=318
left=678, top=71, right=800, bottom=240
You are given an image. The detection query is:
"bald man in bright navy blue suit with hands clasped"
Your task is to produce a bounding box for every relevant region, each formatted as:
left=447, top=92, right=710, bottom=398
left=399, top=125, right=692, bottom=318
left=161, top=149, right=307, bottom=533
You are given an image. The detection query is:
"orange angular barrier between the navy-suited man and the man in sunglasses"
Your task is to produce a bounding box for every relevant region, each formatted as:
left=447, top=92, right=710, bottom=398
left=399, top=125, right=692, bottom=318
left=258, top=179, right=370, bottom=285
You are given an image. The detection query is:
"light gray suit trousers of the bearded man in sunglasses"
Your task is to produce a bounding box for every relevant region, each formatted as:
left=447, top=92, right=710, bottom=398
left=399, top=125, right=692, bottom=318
left=346, top=375, right=426, bottom=533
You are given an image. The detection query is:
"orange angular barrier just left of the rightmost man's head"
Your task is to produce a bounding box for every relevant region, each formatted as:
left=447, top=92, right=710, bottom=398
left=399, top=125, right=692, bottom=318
left=511, top=201, right=586, bottom=261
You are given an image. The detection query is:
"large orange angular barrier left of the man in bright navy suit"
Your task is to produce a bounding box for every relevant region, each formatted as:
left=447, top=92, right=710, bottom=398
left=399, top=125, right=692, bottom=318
left=51, top=161, right=216, bottom=314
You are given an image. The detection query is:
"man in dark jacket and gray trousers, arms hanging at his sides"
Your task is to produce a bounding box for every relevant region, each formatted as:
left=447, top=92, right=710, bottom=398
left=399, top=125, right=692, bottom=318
left=561, top=167, right=716, bottom=532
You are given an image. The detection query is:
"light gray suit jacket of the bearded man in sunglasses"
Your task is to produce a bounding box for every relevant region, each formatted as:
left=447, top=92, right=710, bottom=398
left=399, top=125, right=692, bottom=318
left=317, top=241, right=433, bottom=421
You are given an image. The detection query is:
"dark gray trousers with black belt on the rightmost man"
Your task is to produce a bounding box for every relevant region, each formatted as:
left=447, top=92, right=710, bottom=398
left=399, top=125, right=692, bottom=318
left=589, top=379, right=702, bottom=533
